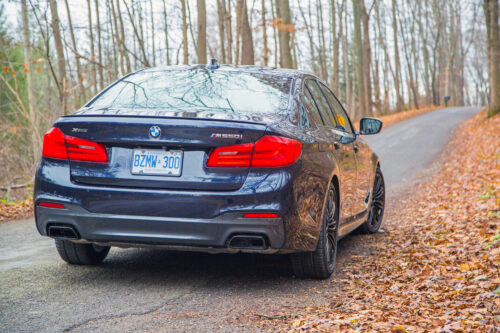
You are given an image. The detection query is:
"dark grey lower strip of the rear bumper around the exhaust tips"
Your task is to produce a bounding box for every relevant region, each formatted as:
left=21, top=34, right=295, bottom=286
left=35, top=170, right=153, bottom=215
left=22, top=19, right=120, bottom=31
left=35, top=204, right=285, bottom=250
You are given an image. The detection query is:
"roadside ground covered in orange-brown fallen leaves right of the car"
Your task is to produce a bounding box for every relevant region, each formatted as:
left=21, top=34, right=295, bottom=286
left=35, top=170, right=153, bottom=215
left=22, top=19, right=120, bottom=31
left=253, top=112, right=500, bottom=332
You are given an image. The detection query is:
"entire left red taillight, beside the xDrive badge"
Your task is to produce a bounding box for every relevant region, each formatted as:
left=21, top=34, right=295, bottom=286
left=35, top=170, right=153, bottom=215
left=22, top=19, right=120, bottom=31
left=42, top=127, right=108, bottom=162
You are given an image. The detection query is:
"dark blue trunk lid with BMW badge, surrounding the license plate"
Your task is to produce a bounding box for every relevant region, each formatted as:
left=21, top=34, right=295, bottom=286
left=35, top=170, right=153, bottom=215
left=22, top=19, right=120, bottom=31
left=56, top=115, right=266, bottom=191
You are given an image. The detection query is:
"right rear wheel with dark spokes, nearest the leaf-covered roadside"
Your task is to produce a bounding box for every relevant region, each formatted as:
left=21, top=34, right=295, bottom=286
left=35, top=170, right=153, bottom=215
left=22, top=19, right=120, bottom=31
left=291, top=184, right=339, bottom=279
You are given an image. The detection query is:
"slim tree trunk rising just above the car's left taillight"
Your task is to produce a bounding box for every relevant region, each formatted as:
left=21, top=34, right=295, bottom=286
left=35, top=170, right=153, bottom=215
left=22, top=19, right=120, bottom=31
left=49, top=0, right=68, bottom=117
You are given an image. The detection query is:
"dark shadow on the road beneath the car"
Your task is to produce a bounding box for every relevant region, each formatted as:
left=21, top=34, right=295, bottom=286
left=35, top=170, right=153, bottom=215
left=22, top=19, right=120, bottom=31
left=58, top=230, right=366, bottom=289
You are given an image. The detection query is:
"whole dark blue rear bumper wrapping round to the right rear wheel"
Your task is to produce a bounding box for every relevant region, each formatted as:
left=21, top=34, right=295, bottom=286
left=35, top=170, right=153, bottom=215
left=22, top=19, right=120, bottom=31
left=34, top=158, right=328, bottom=253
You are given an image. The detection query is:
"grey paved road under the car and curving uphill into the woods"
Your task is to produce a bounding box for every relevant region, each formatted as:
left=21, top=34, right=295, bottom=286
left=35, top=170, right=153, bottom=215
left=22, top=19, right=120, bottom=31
left=0, top=108, right=479, bottom=332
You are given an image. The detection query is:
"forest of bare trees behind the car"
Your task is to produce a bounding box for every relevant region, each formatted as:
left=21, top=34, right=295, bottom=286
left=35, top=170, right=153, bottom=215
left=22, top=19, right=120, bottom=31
left=0, top=0, right=500, bottom=196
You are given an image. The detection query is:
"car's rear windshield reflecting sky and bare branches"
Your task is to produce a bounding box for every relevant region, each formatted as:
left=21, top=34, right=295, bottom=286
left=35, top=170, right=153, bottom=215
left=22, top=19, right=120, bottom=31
left=89, top=69, right=291, bottom=114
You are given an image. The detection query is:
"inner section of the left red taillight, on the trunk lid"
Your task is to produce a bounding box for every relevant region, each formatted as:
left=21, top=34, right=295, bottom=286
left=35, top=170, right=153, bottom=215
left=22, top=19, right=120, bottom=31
left=66, top=136, right=108, bottom=162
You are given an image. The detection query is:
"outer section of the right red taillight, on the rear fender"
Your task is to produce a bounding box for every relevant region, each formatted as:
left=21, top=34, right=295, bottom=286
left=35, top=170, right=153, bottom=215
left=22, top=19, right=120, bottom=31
left=251, top=136, right=302, bottom=167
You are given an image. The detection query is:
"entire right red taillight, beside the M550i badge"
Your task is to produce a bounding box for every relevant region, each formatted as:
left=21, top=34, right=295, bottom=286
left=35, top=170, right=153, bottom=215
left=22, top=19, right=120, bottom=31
left=207, top=136, right=302, bottom=168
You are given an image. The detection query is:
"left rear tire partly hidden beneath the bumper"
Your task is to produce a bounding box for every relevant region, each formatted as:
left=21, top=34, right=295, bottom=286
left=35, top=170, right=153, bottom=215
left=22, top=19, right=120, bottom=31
left=55, top=239, right=110, bottom=265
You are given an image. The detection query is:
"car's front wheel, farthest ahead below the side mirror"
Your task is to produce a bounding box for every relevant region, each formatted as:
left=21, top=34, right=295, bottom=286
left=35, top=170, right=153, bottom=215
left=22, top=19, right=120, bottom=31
left=359, top=167, right=385, bottom=234
